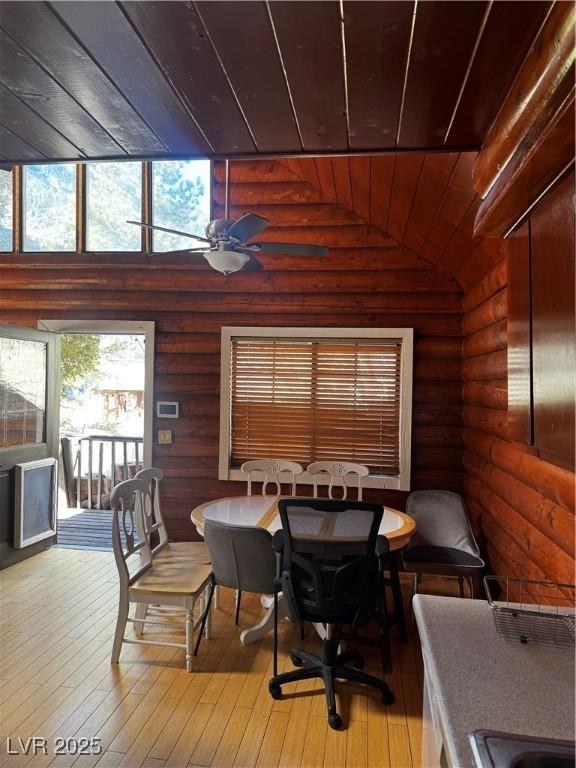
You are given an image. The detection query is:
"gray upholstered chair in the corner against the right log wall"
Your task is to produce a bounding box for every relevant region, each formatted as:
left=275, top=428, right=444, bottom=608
left=402, top=491, right=485, bottom=597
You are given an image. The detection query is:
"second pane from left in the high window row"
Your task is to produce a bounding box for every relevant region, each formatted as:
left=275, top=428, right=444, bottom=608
left=24, top=164, right=76, bottom=251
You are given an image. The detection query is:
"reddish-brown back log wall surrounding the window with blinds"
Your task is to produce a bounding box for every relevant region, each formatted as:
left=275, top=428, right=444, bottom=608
left=0, top=161, right=463, bottom=538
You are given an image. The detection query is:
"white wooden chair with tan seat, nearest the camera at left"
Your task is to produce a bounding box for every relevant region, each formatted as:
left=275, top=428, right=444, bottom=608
left=110, top=479, right=212, bottom=672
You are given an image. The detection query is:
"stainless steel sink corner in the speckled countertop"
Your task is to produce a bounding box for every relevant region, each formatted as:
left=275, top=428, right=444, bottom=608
left=469, top=731, right=576, bottom=768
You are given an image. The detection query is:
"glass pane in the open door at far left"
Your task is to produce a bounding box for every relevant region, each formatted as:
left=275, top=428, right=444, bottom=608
left=0, top=338, right=47, bottom=448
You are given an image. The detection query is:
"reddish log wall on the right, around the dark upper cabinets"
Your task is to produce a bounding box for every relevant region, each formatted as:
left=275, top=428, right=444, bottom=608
left=461, top=177, right=575, bottom=583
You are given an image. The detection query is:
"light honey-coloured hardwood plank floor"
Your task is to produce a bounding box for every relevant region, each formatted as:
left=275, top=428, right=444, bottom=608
left=0, top=548, right=464, bottom=768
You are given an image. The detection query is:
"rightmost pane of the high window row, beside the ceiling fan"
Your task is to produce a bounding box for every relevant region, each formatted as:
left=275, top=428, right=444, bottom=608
left=152, top=160, right=210, bottom=251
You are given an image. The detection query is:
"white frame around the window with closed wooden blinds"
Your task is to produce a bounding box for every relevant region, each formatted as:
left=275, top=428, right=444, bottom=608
left=218, top=326, right=414, bottom=491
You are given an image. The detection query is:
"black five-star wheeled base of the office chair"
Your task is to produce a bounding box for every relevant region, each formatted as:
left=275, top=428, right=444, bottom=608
left=268, top=648, right=394, bottom=730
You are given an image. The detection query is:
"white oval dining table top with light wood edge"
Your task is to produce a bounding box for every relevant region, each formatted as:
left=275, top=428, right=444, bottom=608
left=191, top=496, right=415, bottom=549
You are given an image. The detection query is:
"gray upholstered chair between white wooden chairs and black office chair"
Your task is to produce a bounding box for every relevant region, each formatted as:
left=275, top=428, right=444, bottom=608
left=196, top=520, right=278, bottom=650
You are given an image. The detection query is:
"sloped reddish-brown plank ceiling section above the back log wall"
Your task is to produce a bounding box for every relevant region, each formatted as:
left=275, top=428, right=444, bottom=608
left=270, top=152, right=480, bottom=280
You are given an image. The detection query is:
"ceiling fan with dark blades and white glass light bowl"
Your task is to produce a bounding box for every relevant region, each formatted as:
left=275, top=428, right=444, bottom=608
left=127, top=161, right=328, bottom=275
